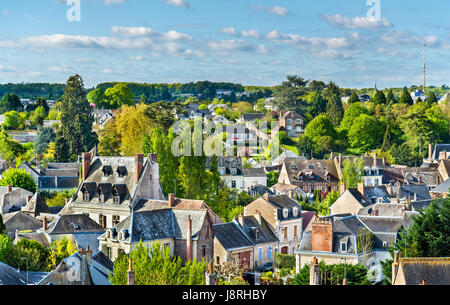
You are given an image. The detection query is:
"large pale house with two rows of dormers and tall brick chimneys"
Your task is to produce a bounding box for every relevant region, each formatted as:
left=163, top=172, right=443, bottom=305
left=60, top=153, right=164, bottom=228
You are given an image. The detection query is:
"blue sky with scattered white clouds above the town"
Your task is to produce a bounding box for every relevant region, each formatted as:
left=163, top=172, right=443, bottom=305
left=0, top=0, right=450, bottom=88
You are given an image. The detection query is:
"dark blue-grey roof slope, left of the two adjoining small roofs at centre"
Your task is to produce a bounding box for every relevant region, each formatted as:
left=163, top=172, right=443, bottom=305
left=213, top=222, right=253, bottom=251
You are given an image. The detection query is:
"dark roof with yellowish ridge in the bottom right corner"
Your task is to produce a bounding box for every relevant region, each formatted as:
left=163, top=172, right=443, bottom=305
left=399, top=257, right=450, bottom=285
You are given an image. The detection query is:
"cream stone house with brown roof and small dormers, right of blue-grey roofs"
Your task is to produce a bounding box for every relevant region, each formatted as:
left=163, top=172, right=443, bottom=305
left=244, top=193, right=303, bottom=254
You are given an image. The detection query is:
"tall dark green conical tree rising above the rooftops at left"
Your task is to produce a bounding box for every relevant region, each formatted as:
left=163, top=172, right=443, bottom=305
left=56, top=75, right=98, bottom=162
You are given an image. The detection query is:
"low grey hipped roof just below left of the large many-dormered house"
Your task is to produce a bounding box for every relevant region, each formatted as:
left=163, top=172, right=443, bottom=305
left=46, top=214, right=105, bottom=234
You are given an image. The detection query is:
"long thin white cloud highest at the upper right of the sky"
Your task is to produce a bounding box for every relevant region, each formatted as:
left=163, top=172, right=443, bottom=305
left=321, top=14, right=392, bottom=29
